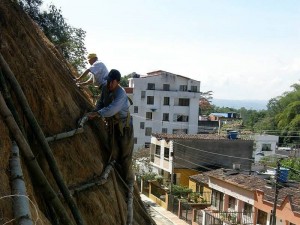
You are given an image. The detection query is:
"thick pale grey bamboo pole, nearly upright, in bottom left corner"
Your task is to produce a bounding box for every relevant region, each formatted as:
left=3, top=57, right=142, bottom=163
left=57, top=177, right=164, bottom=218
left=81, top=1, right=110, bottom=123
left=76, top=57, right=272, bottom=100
left=9, top=142, right=33, bottom=225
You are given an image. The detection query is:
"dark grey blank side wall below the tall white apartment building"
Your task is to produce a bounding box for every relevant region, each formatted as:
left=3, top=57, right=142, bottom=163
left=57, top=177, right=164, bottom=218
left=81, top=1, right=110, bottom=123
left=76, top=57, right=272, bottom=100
left=173, top=139, right=253, bottom=170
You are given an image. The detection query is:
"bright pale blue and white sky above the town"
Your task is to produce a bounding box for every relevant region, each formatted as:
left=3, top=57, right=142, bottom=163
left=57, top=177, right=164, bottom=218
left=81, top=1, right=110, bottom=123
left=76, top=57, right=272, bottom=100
left=44, top=0, right=300, bottom=100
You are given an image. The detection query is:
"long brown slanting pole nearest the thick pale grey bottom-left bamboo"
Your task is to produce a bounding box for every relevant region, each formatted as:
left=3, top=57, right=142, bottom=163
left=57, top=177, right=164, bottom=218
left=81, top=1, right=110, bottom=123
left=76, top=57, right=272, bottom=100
left=0, top=92, right=73, bottom=225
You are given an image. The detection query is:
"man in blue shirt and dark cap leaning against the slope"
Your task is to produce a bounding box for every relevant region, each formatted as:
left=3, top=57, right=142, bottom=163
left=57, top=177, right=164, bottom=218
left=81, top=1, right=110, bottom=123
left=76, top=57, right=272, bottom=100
left=85, top=69, right=134, bottom=185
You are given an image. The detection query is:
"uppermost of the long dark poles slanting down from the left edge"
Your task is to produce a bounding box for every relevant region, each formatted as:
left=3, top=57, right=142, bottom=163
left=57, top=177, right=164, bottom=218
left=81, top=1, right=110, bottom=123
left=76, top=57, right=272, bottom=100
left=0, top=53, right=84, bottom=225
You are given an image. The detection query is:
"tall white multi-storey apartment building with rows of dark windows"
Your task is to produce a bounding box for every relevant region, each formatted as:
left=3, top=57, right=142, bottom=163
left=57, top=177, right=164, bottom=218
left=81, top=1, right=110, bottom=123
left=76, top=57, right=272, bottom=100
left=126, top=70, right=200, bottom=151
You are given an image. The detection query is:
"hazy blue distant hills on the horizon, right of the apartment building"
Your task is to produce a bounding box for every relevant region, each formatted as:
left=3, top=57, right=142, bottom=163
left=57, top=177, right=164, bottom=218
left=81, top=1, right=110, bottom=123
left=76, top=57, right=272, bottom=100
left=212, top=99, right=268, bottom=110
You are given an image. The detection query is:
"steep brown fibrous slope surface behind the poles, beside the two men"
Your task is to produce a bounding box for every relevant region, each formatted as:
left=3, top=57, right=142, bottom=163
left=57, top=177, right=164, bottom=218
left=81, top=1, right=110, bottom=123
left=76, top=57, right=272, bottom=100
left=0, top=0, right=151, bottom=225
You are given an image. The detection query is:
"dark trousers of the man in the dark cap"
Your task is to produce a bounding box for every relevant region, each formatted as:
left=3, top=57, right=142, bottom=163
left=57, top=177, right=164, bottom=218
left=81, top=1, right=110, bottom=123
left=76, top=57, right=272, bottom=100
left=111, top=124, right=134, bottom=184
